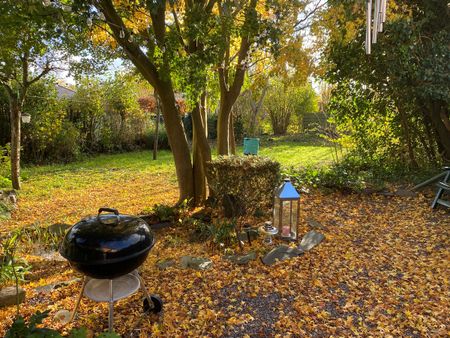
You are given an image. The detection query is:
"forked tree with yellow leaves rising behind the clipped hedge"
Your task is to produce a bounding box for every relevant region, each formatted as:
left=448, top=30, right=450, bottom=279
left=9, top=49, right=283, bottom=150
left=217, top=0, right=314, bottom=155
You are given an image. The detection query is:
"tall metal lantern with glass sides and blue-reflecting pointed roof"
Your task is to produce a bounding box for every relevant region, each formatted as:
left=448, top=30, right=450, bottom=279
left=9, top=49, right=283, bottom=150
left=273, top=178, right=300, bottom=241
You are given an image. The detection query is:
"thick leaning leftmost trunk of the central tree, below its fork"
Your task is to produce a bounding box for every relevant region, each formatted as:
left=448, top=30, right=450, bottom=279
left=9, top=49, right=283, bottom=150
left=155, top=80, right=194, bottom=203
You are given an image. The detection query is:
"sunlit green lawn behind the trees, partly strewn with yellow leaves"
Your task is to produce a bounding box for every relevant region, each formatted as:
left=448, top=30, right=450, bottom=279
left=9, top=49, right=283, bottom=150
left=0, top=139, right=333, bottom=232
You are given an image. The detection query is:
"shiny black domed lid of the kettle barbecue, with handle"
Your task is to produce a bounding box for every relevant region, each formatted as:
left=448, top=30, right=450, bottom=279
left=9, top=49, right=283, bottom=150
left=60, top=208, right=155, bottom=264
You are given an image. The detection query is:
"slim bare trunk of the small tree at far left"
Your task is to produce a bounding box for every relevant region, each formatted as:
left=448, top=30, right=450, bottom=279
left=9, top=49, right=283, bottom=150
left=9, top=95, right=22, bottom=190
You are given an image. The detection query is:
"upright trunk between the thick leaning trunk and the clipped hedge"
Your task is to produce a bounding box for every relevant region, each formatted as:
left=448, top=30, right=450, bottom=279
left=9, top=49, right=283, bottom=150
left=192, top=94, right=211, bottom=205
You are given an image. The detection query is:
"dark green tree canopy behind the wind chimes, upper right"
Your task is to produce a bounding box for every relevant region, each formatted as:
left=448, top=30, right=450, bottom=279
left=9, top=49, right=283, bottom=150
left=323, top=0, right=450, bottom=164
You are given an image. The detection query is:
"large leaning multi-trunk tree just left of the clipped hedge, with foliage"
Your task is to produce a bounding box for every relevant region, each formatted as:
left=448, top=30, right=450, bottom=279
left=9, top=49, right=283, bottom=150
left=74, top=0, right=216, bottom=203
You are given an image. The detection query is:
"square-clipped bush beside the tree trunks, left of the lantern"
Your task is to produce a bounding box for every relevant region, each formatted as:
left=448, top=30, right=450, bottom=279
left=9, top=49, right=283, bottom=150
left=207, top=156, right=280, bottom=217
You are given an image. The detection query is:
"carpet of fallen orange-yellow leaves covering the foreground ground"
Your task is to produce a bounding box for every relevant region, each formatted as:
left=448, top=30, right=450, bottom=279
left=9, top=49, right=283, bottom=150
left=0, top=193, right=450, bottom=337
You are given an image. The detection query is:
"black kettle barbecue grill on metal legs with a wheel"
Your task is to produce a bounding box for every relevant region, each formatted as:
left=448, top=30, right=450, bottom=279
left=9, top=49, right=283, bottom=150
left=60, top=208, right=162, bottom=332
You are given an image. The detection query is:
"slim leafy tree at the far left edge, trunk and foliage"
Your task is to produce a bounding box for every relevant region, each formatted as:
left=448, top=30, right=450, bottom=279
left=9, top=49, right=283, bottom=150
left=0, top=0, right=73, bottom=189
